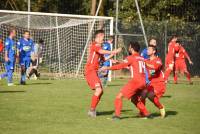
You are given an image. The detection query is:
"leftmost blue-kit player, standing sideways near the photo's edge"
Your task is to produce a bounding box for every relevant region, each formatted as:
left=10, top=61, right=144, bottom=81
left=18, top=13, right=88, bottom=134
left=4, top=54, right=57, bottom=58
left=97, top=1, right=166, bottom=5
left=0, top=29, right=16, bottom=86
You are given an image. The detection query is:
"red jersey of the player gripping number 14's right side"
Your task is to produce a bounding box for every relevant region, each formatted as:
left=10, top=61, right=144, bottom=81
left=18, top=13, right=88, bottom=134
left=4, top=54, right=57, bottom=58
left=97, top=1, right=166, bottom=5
left=146, top=57, right=164, bottom=83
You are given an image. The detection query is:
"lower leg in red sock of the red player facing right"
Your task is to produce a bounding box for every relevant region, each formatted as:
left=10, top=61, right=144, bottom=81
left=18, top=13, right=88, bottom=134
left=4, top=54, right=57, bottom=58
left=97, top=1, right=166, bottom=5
left=88, top=86, right=103, bottom=117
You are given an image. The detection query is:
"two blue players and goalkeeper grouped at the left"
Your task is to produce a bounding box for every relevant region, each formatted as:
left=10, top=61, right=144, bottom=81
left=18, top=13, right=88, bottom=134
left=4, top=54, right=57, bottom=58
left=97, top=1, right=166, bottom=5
left=0, top=29, right=43, bottom=86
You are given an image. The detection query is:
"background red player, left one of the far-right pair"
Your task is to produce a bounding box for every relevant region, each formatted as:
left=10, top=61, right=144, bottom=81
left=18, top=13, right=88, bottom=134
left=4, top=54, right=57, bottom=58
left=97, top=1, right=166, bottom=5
left=165, top=35, right=178, bottom=81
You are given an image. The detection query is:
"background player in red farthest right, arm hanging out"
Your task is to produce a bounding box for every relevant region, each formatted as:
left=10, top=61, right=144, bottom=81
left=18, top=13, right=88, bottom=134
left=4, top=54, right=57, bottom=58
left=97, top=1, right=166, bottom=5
left=174, top=43, right=193, bottom=84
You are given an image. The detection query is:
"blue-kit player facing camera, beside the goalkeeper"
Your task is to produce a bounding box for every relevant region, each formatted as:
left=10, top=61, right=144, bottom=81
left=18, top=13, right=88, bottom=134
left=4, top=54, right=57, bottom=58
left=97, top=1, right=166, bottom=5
left=17, top=31, right=34, bottom=85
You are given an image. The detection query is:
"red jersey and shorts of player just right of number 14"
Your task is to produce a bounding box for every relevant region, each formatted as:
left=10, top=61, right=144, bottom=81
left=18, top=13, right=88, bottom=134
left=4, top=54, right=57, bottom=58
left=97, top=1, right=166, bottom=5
left=146, top=57, right=166, bottom=98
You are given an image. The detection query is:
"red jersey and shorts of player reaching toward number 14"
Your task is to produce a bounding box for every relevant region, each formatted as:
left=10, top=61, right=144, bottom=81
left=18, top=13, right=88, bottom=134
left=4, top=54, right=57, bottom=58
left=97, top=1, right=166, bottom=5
left=85, top=42, right=103, bottom=90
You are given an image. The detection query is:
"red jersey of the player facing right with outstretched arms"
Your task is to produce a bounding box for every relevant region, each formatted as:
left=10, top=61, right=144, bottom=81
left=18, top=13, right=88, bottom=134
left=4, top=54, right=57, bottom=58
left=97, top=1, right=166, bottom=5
left=85, top=42, right=103, bottom=71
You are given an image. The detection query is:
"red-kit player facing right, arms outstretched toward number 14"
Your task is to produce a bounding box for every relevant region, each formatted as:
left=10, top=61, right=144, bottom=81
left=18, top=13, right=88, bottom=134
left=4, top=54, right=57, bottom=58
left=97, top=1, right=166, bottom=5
left=85, top=30, right=121, bottom=117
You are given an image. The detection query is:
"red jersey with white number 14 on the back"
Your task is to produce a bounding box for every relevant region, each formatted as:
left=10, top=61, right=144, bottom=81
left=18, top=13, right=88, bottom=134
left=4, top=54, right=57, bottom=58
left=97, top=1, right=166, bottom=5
left=111, top=53, right=145, bottom=80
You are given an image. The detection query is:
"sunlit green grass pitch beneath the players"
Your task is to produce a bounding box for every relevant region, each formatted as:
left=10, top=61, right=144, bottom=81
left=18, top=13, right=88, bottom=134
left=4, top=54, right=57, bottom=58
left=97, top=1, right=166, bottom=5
left=0, top=80, right=200, bottom=134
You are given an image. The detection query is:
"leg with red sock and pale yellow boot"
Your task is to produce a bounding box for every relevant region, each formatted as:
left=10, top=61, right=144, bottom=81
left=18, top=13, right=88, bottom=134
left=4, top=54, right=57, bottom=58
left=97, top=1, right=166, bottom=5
left=148, top=91, right=166, bottom=118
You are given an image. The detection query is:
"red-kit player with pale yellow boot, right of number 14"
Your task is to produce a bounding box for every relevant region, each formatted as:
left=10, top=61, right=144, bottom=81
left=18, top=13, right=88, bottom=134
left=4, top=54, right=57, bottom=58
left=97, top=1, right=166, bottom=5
left=131, top=45, right=166, bottom=118
